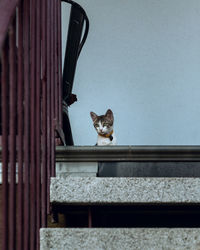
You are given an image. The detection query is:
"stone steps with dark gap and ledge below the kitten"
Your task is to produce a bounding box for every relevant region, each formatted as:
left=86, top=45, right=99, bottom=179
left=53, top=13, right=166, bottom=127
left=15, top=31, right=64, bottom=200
left=40, top=146, right=200, bottom=250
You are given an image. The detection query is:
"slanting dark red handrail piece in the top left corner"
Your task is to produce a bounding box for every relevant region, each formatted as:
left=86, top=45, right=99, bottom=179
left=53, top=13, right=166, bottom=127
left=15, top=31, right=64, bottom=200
left=0, top=0, right=19, bottom=50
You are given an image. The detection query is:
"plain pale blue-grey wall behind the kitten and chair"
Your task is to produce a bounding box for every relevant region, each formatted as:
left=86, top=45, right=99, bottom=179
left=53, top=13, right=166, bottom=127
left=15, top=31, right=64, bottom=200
left=63, top=0, right=200, bottom=145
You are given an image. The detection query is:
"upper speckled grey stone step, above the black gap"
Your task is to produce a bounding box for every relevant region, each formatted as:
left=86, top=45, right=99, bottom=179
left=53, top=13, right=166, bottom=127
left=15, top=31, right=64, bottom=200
left=50, top=177, right=200, bottom=204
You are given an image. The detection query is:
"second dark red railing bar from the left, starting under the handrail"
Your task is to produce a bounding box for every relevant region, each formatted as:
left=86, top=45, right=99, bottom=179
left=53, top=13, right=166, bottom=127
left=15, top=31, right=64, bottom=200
left=9, top=20, right=17, bottom=250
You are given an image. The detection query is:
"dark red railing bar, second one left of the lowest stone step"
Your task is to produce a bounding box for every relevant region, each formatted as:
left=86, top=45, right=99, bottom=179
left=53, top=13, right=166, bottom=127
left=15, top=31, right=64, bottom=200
left=30, top=0, right=36, bottom=247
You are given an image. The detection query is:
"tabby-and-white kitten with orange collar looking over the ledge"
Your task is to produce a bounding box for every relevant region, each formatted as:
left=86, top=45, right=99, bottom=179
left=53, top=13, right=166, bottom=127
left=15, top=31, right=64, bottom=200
left=90, top=109, right=117, bottom=146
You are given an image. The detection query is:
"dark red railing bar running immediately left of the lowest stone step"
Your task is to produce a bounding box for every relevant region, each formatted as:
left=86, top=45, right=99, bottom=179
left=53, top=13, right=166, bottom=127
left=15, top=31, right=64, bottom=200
left=36, top=0, right=41, bottom=250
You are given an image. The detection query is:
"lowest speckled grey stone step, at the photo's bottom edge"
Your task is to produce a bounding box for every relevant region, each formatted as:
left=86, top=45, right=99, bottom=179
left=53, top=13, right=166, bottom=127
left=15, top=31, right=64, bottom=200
left=40, top=228, right=200, bottom=250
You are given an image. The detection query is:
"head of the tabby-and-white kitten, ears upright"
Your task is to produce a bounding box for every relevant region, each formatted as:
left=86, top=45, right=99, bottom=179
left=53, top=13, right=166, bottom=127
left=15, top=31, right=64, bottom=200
left=90, top=109, right=114, bottom=135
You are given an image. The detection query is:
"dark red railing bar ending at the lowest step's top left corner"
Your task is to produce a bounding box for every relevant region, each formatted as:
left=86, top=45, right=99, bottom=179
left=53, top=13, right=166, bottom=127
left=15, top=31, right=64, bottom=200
left=41, top=0, right=48, bottom=227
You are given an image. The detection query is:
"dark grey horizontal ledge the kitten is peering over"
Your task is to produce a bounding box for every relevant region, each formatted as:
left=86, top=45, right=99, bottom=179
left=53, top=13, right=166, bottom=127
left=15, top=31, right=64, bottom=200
left=56, top=146, right=200, bottom=162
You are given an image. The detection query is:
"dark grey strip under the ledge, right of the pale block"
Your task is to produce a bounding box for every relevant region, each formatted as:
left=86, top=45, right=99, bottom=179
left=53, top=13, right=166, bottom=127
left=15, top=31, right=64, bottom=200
left=98, top=162, right=200, bottom=177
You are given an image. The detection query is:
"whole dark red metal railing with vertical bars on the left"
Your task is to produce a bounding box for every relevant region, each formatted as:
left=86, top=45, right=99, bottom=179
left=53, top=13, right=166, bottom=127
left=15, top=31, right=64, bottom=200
left=0, top=0, right=62, bottom=250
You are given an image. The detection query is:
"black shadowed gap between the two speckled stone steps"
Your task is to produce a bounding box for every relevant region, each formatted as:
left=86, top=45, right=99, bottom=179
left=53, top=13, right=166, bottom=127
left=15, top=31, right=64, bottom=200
left=53, top=204, right=200, bottom=228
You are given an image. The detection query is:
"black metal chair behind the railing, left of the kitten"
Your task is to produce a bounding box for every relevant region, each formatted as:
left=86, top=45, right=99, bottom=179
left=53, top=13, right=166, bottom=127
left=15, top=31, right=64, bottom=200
left=62, top=0, right=89, bottom=145
